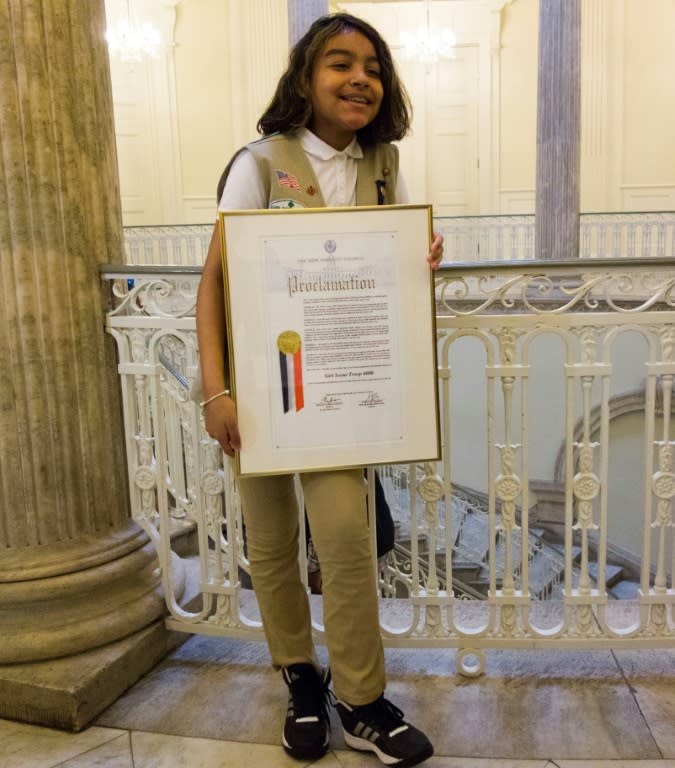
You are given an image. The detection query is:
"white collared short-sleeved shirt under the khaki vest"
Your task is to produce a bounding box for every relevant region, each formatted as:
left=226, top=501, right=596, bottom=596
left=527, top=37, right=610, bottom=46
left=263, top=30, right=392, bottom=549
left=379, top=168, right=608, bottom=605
left=218, top=128, right=408, bottom=211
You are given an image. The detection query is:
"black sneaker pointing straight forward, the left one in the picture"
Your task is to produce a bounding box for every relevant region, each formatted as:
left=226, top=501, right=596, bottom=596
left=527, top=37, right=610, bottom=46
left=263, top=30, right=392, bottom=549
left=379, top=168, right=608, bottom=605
left=281, top=664, right=330, bottom=760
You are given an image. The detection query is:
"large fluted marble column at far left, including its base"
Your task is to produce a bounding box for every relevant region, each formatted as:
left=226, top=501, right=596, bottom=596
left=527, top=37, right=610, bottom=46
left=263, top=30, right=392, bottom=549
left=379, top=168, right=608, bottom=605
left=0, top=0, right=177, bottom=729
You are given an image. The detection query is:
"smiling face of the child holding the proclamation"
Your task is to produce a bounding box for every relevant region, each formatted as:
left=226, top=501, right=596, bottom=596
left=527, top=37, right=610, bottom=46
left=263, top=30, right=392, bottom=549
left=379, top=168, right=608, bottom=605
left=307, top=30, right=383, bottom=149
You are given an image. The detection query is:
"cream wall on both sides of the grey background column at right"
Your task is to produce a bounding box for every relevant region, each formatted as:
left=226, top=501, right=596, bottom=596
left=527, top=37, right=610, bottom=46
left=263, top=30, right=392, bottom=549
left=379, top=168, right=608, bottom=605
left=499, top=0, right=675, bottom=213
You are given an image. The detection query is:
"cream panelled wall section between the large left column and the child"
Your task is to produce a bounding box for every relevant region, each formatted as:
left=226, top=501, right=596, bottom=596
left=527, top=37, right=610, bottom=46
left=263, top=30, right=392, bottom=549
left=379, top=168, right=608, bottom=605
left=106, top=0, right=288, bottom=225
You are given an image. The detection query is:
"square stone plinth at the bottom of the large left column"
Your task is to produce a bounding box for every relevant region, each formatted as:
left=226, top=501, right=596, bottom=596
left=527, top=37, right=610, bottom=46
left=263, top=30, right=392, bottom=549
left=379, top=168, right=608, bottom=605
left=0, top=619, right=190, bottom=731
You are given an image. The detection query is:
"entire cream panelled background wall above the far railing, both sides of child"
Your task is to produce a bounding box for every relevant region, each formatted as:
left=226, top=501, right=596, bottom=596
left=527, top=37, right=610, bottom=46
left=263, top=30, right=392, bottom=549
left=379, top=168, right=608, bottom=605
left=106, top=0, right=675, bottom=224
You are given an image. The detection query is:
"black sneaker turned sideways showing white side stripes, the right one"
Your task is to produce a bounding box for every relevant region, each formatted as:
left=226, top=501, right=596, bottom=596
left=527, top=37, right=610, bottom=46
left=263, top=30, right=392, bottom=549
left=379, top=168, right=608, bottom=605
left=336, top=696, right=434, bottom=768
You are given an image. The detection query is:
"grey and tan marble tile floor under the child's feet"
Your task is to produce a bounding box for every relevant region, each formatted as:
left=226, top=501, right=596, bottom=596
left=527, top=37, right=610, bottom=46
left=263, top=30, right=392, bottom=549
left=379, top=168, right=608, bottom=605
left=0, top=636, right=675, bottom=768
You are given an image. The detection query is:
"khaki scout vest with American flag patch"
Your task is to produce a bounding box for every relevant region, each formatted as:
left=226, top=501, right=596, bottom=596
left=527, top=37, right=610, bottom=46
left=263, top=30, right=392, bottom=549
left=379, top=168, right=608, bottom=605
left=246, top=133, right=398, bottom=208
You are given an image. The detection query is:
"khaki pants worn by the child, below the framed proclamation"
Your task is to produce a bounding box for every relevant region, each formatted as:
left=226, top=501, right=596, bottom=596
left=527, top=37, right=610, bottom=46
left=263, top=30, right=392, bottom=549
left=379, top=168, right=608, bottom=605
left=239, top=469, right=385, bottom=706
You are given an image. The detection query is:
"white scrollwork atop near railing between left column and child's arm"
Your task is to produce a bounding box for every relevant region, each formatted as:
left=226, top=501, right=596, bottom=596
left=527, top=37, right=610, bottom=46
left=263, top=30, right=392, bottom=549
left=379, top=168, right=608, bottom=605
left=110, top=277, right=198, bottom=318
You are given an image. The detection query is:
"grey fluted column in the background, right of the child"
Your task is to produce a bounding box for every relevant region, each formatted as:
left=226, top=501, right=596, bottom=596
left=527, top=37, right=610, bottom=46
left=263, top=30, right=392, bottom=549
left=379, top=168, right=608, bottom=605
left=535, top=0, right=581, bottom=261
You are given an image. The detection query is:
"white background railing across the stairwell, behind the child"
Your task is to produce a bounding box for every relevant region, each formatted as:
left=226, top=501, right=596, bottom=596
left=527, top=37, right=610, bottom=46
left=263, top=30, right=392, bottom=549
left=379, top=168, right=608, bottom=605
left=124, top=211, right=675, bottom=266
